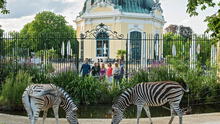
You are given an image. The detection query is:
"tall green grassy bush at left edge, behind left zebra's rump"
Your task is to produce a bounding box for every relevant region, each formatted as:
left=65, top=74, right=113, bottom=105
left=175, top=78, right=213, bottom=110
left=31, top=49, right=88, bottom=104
left=1, top=71, right=32, bottom=107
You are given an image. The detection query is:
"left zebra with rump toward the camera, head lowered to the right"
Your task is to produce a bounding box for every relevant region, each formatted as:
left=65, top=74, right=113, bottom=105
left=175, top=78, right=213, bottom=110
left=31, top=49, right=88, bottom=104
left=22, top=84, right=78, bottom=124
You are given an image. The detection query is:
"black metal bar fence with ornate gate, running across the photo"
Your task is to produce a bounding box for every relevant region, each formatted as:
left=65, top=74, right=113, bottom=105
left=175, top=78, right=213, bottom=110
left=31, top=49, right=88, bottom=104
left=0, top=31, right=217, bottom=79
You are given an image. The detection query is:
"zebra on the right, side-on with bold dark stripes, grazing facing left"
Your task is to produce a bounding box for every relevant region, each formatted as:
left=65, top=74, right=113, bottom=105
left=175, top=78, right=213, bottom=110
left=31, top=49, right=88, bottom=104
left=112, top=81, right=189, bottom=124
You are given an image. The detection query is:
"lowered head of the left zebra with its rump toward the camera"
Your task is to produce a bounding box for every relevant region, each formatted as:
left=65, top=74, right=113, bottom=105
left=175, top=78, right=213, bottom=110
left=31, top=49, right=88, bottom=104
left=66, top=107, right=79, bottom=124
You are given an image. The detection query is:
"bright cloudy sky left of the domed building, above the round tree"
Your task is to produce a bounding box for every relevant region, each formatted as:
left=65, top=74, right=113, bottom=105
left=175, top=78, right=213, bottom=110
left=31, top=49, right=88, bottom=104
left=0, top=0, right=83, bottom=32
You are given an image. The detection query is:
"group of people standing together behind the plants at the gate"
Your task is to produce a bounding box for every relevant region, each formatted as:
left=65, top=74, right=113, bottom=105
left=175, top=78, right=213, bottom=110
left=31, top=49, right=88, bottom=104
left=80, top=59, right=124, bottom=83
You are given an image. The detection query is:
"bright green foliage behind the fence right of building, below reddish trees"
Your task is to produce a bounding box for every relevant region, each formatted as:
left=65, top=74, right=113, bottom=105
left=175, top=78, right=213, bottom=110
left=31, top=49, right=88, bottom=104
left=163, top=33, right=214, bottom=66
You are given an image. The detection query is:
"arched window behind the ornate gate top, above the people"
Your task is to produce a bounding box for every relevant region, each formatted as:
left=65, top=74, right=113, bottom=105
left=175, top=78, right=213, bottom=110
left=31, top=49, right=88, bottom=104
left=96, top=32, right=109, bottom=57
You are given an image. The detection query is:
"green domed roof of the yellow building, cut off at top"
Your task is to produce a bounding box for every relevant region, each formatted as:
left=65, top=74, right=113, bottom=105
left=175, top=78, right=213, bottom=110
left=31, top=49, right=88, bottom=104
left=81, top=0, right=155, bottom=14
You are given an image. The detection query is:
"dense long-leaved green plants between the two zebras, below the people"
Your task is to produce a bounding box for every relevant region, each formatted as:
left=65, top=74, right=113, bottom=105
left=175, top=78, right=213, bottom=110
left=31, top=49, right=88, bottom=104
left=52, top=71, right=108, bottom=104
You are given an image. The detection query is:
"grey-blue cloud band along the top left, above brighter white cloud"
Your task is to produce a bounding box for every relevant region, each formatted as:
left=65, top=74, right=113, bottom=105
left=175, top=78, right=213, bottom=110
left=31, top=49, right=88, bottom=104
left=0, top=0, right=77, bottom=18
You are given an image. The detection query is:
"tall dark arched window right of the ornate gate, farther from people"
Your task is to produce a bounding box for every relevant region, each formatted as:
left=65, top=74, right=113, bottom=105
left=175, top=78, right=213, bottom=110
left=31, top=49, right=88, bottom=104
left=130, top=31, right=141, bottom=61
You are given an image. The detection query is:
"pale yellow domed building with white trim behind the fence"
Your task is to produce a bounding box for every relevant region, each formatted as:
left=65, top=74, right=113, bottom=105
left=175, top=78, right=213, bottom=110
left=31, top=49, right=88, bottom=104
left=75, top=0, right=165, bottom=59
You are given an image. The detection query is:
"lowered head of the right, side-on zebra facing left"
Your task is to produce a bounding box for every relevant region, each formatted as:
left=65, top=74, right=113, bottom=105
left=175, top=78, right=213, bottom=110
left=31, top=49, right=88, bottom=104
left=112, top=105, right=123, bottom=124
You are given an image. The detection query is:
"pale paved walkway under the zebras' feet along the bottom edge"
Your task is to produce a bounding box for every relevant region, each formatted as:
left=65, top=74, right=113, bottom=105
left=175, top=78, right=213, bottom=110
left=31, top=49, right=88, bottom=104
left=0, top=113, right=220, bottom=124
